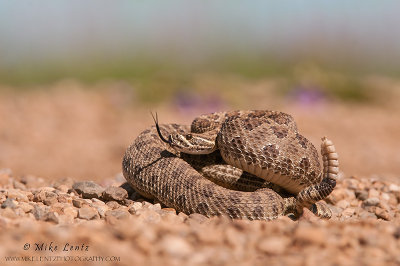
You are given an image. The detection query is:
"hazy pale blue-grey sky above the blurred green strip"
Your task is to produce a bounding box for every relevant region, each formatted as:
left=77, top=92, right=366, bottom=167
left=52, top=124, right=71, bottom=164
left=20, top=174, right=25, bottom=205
left=0, top=0, right=400, bottom=66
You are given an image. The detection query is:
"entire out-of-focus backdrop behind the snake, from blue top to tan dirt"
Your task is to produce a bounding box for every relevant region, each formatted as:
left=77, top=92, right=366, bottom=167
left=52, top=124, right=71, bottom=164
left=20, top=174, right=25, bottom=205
left=0, top=0, right=400, bottom=180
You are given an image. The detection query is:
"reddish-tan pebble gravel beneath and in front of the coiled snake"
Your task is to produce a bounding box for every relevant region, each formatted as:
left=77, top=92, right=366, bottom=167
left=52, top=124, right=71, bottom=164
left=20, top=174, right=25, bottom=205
left=0, top=169, right=400, bottom=265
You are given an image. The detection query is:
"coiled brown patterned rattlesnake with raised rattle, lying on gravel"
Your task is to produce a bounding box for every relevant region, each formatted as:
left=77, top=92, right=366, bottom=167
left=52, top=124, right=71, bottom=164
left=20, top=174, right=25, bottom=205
left=122, top=111, right=338, bottom=220
